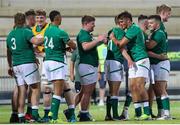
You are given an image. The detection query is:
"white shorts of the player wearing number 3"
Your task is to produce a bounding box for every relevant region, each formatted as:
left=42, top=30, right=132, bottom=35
left=13, top=63, right=40, bottom=86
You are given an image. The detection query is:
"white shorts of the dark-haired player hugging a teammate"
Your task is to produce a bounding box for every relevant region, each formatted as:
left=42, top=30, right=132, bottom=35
left=129, top=58, right=150, bottom=79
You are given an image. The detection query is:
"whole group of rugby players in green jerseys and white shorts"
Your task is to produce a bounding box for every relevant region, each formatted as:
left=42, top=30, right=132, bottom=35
left=7, top=4, right=172, bottom=123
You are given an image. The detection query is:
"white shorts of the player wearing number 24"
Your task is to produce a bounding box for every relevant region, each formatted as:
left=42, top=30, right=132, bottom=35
left=44, top=60, right=65, bottom=81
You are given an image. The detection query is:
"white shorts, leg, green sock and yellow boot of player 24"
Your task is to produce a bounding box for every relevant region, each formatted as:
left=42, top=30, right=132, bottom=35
left=44, top=61, right=65, bottom=123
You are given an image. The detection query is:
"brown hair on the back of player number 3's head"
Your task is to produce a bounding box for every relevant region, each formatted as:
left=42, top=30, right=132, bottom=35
left=14, top=12, right=26, bottom=26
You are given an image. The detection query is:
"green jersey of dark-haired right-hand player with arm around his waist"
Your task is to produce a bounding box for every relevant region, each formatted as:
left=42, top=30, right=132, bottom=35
left=149, top=29, right=167, bottom=64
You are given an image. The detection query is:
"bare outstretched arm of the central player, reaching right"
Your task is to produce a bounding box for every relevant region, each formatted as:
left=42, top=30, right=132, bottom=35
left=82, top=34, right=107, bottom=51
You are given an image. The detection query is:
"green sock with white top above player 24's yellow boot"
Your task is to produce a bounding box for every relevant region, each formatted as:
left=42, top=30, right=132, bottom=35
left=49, top=95, right=61, bottom=120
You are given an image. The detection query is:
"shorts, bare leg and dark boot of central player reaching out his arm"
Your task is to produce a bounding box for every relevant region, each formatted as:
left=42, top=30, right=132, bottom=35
left=78, top=64, right=98, bottom=121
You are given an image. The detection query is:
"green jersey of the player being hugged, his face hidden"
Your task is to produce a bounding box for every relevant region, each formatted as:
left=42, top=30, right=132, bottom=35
left=106, top=27, right=125, bottom=63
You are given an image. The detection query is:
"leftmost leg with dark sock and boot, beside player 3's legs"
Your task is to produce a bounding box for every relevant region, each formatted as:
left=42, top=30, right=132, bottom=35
left=10, top=85, right=19, bottom=123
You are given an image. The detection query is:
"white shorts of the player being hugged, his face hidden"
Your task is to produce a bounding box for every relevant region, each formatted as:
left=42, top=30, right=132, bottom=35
left=104, top=60, right=123, bottom=81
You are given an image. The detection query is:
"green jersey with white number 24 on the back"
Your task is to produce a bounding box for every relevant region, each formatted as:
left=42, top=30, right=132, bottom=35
left=44, top=24, right=70, bottom=63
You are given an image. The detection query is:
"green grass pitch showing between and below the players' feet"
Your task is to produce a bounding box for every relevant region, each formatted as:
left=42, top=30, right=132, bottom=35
left=0, top=101, right=180, bottom=124
